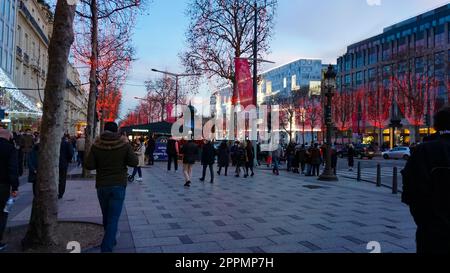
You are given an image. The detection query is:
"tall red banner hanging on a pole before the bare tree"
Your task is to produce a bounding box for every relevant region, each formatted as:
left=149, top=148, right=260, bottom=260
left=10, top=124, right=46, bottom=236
left=234, top=58, right=253, bottom=108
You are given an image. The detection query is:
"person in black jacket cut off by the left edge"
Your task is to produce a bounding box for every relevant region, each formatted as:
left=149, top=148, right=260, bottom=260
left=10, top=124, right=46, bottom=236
left=0, top=127, right=19, bottom=251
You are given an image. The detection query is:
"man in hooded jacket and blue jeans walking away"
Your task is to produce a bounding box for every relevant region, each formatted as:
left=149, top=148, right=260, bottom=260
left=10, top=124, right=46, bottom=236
left=85, top=122, right=139, bottom=252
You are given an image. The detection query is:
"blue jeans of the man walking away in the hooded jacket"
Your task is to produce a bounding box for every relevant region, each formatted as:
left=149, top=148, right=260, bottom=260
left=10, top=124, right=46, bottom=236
left=97, top=186, right=126, bottom=253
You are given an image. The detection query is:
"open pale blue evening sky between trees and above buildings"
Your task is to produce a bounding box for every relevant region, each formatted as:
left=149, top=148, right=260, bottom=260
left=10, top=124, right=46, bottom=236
left=121, top=0, right=449, bottom=116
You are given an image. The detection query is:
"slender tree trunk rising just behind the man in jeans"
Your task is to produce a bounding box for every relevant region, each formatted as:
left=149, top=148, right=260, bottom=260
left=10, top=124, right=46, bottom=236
left=83, top=0, right=98, bottom=177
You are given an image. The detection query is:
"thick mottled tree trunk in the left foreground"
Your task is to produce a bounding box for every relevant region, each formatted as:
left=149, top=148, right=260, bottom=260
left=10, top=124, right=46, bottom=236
left=22, top=0, right=76, bottom=248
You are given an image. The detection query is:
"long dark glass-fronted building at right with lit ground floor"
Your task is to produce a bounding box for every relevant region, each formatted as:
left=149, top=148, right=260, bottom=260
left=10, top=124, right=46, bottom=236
left=337, top=4, right=450, bottom=147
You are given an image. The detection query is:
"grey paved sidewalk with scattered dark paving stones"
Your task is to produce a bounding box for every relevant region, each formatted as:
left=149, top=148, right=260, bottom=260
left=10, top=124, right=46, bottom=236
left=10, top=163, right=415, bottom=253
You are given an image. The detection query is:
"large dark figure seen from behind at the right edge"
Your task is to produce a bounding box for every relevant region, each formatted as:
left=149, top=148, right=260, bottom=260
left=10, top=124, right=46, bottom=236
left=402, top=107, right=450, bottom=255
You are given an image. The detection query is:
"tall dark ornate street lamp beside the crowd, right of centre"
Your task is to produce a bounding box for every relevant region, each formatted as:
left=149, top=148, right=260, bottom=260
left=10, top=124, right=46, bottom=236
left=319, top=64, right=339, bottom=181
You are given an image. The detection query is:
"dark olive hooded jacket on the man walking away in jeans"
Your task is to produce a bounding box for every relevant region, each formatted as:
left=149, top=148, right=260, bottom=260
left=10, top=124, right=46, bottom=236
left=85, top=131, right=139, bottom=188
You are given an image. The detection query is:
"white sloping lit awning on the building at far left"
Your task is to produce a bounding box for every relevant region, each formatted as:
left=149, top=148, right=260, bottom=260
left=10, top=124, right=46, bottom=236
left=0, top=69, right=42, bottom=116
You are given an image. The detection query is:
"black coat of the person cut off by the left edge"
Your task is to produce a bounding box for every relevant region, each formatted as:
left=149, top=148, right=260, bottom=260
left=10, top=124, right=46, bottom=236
left=0, top=138, right=19, bottom=190
